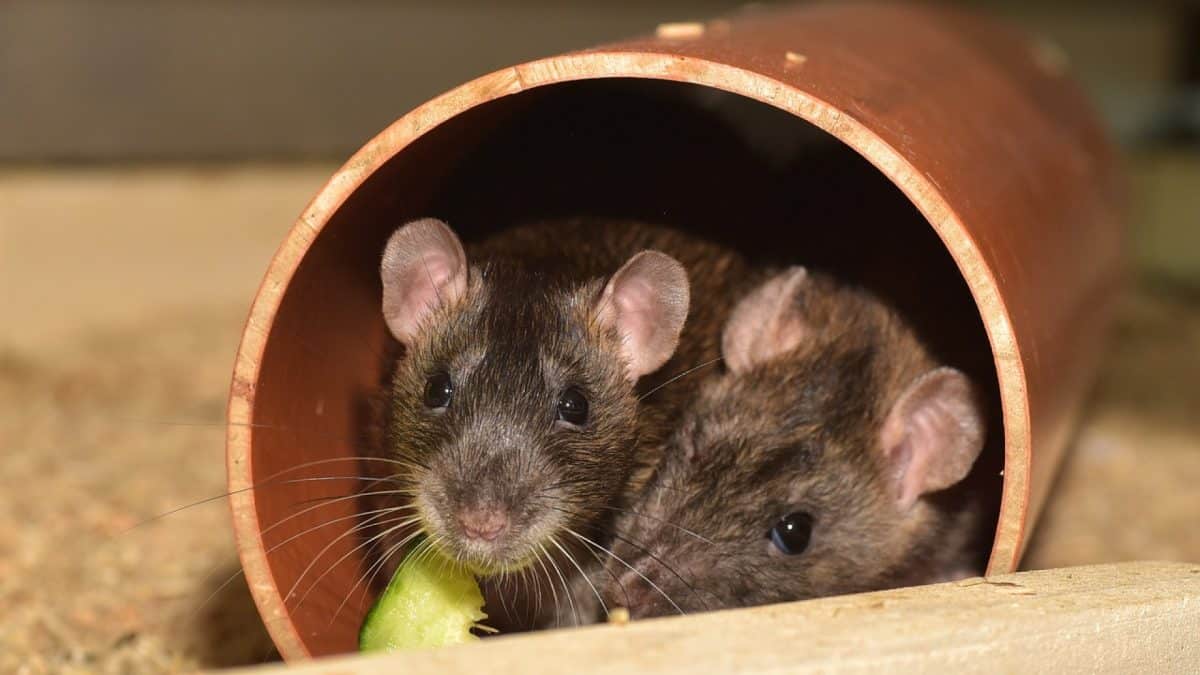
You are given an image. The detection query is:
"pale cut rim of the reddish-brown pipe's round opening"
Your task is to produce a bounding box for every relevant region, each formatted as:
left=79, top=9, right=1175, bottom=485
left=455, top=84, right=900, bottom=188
left=226, top=49, right=1032, bottom=659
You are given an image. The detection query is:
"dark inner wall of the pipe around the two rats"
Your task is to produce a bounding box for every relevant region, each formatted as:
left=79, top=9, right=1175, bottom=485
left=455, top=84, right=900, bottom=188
left=253, top=79, right=1003, bottom=655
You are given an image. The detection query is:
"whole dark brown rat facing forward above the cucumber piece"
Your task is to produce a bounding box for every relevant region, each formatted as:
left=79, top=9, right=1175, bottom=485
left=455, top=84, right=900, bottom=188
left=367, top=219, right=752, bottom=631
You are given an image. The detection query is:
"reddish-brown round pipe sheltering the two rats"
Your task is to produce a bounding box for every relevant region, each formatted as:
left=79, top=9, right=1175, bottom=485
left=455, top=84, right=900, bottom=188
left=228, top=4, right=1123, bottom=659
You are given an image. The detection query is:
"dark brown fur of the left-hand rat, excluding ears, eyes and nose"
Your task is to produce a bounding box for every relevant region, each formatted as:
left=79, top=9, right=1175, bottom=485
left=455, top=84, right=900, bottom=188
left=371, top=220, right=755, bottom=627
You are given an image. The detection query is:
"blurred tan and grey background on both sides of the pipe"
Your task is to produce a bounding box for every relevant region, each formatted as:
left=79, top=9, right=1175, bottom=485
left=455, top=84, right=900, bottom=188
left=0, top=0, right=1200, bottom=673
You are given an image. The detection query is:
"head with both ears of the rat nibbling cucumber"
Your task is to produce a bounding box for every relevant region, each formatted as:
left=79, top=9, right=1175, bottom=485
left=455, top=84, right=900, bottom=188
left=382, top=220, right=689, bottom=574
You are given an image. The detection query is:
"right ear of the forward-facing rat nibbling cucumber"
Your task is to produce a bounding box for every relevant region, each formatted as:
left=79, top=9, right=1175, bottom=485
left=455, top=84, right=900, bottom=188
left=595, top=251, right=690, bottom=382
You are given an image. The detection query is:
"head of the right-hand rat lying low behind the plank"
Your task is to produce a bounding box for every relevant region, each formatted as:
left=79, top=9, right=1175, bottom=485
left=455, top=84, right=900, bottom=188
left=605, top=268, right=984, bottom=616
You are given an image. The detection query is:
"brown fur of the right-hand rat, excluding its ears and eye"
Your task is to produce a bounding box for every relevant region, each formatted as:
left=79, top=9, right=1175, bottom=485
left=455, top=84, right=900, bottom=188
left=576, top=267, right=977, bottom=617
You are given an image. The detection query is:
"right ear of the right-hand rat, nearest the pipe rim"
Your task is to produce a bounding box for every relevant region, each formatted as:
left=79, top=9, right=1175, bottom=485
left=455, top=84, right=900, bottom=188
left=882, top=368, right=984, bottom=510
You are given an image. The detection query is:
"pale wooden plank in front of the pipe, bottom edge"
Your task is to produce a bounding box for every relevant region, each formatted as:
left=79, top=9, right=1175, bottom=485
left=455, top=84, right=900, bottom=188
left=213, top=562, right=1200, bottom=675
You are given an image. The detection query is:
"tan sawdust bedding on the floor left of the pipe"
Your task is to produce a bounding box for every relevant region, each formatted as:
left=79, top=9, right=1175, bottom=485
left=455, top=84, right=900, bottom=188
left=0, top=309, right=274, bottom=674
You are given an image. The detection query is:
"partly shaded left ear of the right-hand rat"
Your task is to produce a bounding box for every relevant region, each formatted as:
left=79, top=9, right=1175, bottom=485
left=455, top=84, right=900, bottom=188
left=721, top=267, right=809, bottom=372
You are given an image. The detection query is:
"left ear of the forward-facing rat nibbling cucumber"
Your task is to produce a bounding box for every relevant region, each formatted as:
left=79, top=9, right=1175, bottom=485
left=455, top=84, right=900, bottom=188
left=379, top=219, right=467, bottom=346
